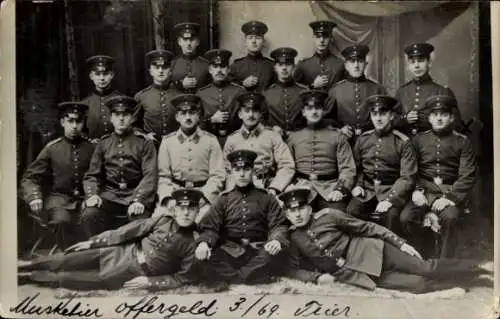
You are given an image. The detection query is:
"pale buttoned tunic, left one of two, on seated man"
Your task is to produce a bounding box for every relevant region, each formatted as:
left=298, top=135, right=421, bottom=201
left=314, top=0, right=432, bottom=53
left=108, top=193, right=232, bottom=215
left=158, top=128, right=225, bottom=204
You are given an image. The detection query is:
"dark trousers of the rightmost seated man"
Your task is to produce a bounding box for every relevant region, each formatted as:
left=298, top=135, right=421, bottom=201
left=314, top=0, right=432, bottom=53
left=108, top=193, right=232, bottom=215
left=400, top=202, right=460, bottom=258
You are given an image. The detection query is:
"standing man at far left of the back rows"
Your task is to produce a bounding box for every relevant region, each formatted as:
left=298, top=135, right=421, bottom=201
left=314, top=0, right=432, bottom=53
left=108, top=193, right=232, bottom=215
left=82, top=55, right=121, bottom=141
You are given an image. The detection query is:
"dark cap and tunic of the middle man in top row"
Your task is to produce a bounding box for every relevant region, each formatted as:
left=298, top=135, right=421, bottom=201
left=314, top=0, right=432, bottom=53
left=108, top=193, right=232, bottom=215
left=229, top=21, right=274, bottom=92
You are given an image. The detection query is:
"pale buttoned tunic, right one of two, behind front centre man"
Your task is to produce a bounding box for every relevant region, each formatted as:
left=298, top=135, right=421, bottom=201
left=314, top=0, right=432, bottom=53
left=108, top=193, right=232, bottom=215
left=224, top=124, right=295, bottom=192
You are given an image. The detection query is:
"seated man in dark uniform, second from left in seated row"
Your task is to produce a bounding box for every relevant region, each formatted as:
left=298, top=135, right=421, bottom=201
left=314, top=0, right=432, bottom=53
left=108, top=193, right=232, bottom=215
left=80, top=96, right=158, bottom=237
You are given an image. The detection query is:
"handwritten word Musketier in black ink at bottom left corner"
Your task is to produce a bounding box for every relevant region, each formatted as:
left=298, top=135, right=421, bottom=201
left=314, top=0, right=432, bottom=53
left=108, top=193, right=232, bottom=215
left=9, top=293, right=102, bottom=318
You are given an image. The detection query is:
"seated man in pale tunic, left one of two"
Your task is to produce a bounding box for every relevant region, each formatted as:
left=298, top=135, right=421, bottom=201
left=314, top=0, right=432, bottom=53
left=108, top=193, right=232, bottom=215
left=157, top=94, right=225, bottom=224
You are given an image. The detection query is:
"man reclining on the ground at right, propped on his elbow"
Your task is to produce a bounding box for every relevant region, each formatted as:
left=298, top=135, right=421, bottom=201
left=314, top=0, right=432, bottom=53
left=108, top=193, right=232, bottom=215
left=280, top=189, right=489, bottom=293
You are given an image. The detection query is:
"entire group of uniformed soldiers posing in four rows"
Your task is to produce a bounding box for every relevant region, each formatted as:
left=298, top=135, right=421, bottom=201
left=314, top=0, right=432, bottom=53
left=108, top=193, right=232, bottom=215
left=19, top=21, right=484, bottom=292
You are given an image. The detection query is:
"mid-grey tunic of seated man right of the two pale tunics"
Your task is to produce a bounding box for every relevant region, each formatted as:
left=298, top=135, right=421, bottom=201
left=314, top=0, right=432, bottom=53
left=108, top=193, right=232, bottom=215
left=288, top=124, right=356, bottom=200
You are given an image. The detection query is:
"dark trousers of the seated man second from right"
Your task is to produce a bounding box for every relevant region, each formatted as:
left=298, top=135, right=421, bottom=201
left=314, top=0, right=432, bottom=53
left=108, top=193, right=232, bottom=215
left=347, top=197, right=401, bottom=234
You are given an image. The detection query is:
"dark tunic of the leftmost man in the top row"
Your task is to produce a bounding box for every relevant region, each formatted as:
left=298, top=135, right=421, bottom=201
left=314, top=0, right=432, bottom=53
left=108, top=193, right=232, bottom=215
left=172, top=55, right=210, bottom=93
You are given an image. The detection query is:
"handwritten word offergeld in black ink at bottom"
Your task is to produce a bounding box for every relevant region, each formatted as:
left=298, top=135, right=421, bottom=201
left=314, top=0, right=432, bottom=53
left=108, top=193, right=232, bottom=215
left=115, top=296, right=217, bottom=319
